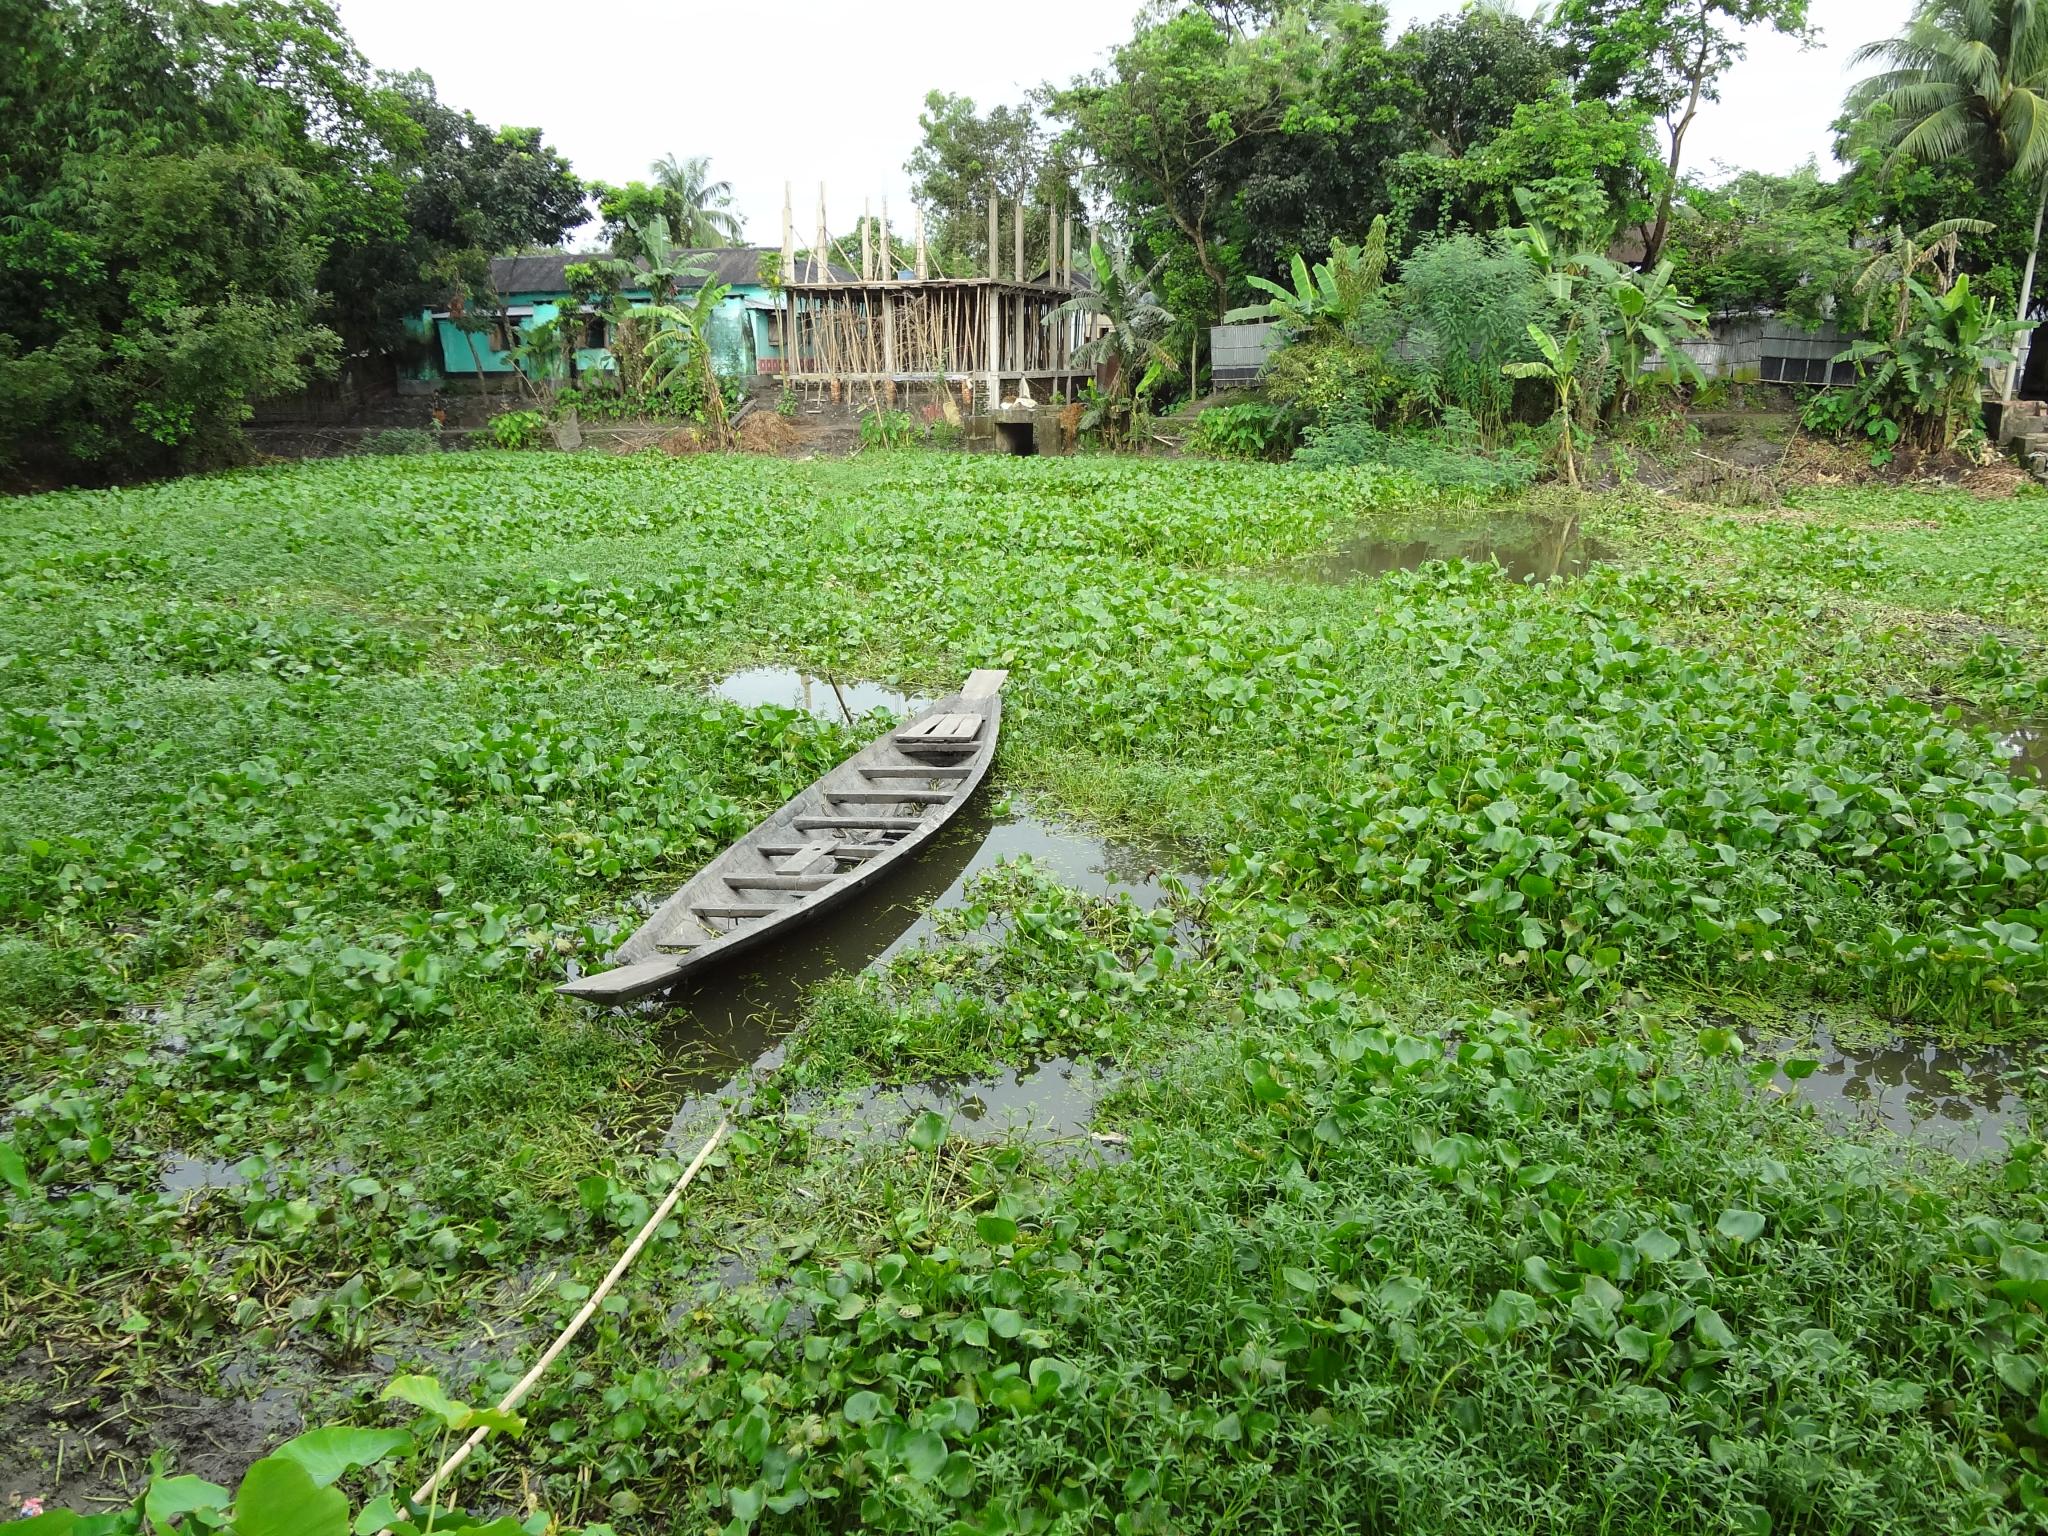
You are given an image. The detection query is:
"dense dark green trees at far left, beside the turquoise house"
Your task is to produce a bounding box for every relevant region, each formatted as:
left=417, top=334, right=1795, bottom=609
left=0, top=0, right=582, bottom=475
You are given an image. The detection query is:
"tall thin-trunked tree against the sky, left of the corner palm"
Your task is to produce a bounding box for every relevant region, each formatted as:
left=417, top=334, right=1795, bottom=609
left=1552, top=0, right=1812, bottom=266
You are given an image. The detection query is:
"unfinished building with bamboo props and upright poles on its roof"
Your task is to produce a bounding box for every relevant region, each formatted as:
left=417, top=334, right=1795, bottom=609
left=780, top=193, right=1094, bottom=410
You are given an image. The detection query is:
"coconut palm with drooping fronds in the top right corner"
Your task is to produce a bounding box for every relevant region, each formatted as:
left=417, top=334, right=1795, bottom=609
left=1849, top=0, right=2048, bottom=399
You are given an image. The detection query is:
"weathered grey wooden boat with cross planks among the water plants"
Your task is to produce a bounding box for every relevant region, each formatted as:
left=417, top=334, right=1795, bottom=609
left=557, top=672, right=1010, bottom=1004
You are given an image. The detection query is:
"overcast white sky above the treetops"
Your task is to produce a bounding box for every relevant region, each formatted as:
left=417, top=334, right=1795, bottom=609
left=327, top=0, right=1911, bottom=246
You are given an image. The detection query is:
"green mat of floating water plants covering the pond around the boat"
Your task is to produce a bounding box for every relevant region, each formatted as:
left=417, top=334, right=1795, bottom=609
left=0, top=455, right=2048, bottom=1532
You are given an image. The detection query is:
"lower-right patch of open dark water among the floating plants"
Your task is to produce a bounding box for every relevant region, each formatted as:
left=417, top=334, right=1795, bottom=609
left=1767, top=1028, right=2036, bottom=1157
